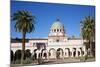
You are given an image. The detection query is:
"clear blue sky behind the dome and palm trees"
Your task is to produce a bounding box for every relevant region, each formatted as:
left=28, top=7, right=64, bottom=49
left=10, top=1, right=95, bottom=38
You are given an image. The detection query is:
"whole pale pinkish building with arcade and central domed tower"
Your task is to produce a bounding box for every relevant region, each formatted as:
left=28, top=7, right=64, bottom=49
left=11, top=19, right=86, bottom=59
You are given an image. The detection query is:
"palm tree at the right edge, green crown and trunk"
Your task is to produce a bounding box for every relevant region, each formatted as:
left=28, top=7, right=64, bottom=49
left=81, top=16, right=95, bottom=56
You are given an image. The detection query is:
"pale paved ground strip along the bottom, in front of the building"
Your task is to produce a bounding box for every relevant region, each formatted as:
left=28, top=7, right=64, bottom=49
left=11, top=58, right=95, bottom=67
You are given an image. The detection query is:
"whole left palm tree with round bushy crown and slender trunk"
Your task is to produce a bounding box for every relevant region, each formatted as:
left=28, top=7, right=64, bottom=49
left=12, top=10, right=35, bottom=63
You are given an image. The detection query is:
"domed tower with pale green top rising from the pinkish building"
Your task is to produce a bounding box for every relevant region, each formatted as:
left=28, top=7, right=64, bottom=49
left=48, top=19, right=67, bottom=45
